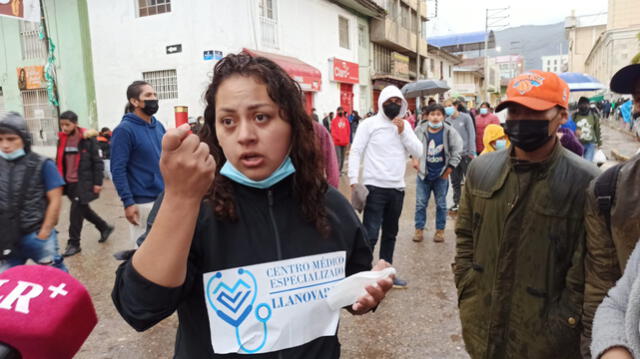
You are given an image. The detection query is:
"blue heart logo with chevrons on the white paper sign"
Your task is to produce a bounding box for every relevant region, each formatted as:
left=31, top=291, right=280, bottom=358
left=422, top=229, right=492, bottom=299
left=207, top=268, right=258, bottom=327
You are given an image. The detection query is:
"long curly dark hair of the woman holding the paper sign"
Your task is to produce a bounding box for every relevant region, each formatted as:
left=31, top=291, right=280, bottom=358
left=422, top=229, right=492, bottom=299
left=199, top=52, right=330, bottom=237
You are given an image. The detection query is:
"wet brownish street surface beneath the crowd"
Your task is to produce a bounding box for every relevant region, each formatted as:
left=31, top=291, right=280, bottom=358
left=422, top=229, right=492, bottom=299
left=57, top=122, right=640, bottom=359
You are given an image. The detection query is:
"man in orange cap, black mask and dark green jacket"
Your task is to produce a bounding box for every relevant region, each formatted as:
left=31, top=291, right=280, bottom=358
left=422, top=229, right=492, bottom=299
left=454, top=71, right=598, bottom=359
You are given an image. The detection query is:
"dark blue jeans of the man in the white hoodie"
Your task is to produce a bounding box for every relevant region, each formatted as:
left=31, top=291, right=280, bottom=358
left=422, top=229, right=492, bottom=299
left=362, top=185, right=404, bottom=263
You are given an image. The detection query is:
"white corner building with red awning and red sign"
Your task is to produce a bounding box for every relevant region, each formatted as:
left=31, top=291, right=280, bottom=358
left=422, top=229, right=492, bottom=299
left=88, top=0, right=376, bottom=127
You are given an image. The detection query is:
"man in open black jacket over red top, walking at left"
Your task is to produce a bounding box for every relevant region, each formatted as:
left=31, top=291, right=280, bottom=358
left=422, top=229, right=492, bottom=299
left=56, top=111, right=114, bottom=257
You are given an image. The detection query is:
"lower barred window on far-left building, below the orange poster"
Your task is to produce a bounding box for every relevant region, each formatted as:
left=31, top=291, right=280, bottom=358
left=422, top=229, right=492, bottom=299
left=20, top=89, right=58, bottom=146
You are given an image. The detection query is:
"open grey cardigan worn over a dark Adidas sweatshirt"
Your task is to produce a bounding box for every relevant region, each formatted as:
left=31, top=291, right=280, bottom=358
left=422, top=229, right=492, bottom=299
left=416, top=121, right=463, bottom=180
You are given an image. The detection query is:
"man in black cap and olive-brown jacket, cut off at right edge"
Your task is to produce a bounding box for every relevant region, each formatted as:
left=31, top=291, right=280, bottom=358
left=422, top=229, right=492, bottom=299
left=582, top=64, right=640, bottom=358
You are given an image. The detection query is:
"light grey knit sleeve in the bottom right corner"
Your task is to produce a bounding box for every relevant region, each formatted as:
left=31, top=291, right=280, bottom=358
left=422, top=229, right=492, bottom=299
left=591, top=240, right=640, bottom=358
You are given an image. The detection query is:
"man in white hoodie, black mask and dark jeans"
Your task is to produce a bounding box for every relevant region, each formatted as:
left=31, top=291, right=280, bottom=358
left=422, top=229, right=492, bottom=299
left=349, top=86, right=422, bottom=288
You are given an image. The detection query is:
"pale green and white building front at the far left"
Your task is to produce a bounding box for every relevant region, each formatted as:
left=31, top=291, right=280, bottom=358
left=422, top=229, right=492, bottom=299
left=0, top=0, right=98, bottom=156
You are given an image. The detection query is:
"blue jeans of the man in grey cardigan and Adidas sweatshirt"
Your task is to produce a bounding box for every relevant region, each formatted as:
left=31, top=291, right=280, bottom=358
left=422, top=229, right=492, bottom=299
left=416, top=176, right=449, bottom=229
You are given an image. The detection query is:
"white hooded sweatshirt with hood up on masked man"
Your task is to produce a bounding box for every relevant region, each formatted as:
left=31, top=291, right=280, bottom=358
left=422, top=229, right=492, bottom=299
left=348, top=86, right=422, bottom=189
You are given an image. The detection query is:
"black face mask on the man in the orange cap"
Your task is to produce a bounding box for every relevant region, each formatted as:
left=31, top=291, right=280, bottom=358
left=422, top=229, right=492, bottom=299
left=505, top=120, right=553, bottom=152
